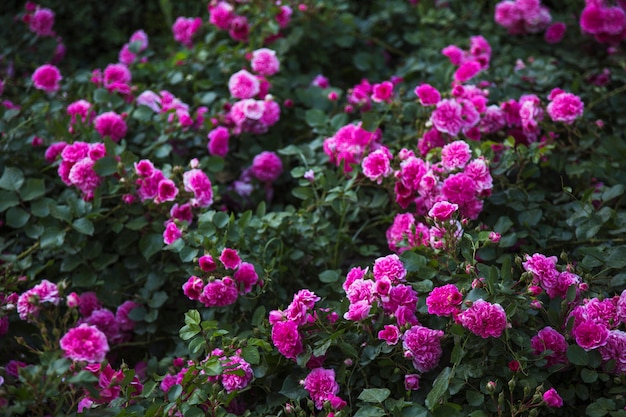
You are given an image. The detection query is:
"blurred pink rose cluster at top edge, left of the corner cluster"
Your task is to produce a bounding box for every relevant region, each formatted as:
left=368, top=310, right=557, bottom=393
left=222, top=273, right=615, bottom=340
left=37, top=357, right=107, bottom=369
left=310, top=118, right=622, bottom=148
left=495, top=0, right=552, bottom=35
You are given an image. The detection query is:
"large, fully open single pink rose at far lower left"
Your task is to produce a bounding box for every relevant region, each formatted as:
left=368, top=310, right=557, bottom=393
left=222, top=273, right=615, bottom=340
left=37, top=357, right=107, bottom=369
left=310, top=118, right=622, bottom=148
left=59, top=323, right=109, bottom=363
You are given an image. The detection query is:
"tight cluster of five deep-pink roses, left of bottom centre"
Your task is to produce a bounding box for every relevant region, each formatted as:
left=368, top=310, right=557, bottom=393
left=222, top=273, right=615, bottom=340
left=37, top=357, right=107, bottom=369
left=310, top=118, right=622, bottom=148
left=183, top=248, right=259, bottom=307
